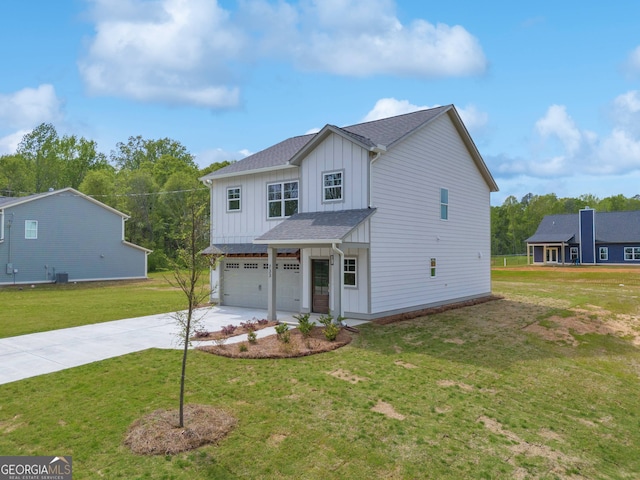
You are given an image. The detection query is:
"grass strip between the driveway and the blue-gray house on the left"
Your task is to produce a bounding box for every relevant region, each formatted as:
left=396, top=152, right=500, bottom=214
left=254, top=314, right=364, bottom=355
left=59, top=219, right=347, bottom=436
left=0, top=272, right=208, bottom=338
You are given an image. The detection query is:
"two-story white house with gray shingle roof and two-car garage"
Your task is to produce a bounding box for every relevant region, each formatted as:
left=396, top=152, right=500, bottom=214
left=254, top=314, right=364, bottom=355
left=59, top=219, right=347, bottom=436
left=201, top=105, right=498, bottom=319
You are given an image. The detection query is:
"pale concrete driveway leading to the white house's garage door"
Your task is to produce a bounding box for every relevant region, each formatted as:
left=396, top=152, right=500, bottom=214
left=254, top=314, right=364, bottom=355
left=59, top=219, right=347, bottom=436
left=0, top=306, right=362, bottom=385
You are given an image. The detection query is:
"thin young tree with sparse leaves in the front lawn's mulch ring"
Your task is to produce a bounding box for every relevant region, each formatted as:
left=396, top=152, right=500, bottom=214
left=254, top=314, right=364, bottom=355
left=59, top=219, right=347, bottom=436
left=170, top=191, right=212, bottom=428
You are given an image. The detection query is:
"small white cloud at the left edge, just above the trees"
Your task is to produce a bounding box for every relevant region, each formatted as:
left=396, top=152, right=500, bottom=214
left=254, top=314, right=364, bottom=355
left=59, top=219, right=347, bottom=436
left=0, top=84, right=63, bottom=129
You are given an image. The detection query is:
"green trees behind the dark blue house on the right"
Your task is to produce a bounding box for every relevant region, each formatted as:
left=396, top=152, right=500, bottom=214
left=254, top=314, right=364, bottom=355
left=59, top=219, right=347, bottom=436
left=491, top=193, right=640, bottom=255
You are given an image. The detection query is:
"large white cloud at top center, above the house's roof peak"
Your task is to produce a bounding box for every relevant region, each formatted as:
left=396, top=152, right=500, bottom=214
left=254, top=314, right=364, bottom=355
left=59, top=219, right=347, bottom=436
left=268, top=0, right=487, bottom=78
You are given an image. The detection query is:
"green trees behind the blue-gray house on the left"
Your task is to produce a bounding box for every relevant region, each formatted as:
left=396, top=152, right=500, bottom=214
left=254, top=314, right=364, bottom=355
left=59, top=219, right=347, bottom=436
left=0, top=123, right=230, bottom=271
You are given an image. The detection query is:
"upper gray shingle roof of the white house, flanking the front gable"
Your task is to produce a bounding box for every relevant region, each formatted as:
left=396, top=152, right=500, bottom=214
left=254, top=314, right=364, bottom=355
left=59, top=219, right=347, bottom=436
left=204, top=105, right=452, bottom=178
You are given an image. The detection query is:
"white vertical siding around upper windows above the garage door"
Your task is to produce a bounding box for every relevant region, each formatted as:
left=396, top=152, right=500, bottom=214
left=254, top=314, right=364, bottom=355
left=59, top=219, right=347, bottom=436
left=211, top=167, right=303, bottom=244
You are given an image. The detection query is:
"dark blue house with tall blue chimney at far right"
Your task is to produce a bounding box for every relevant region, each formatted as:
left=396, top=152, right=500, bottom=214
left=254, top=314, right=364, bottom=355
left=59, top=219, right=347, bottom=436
left=527, top=207, right=640, bottom=265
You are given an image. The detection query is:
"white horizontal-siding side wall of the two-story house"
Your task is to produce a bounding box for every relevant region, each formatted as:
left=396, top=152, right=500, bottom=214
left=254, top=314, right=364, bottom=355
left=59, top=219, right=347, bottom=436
left=370, top=115, right=491, bottom=314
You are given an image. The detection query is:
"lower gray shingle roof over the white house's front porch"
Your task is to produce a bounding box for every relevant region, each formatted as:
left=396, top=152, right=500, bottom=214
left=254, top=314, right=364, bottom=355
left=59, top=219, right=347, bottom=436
left=256, top=208, right=376, bottom=243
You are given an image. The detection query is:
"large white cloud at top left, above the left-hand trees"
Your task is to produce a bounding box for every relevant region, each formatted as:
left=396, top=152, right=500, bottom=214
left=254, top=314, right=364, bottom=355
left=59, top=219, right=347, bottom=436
left=79, top=0, right=245, bottom=108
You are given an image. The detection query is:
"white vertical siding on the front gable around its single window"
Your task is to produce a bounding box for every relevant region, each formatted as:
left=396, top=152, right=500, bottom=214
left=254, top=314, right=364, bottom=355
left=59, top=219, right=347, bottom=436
left=300, top=133, right=369, bottom=212
